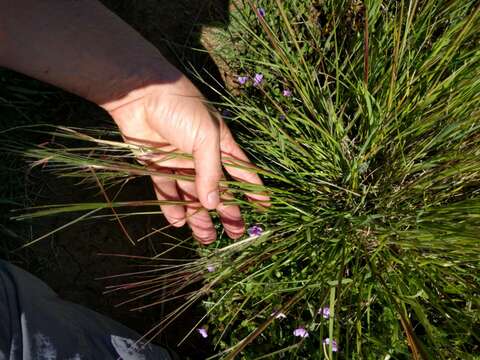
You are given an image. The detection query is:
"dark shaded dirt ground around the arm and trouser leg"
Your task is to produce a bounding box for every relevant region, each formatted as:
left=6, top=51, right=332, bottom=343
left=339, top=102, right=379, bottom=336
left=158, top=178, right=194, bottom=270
left=0, top=0, right=234, bottom=359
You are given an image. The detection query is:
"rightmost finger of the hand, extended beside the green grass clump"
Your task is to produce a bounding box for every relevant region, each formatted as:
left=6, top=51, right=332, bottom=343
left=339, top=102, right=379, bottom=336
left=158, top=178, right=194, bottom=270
left=220, top=124, right=270, bottom=206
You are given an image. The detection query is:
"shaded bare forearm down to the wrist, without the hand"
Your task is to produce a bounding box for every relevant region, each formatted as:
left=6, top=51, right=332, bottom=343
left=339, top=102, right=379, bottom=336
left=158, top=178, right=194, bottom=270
left=0, top=0, right=182, bottom=111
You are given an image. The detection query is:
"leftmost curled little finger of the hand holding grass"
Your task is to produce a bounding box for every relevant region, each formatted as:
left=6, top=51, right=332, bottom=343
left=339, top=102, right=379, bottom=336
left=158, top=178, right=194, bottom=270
left=152, top=172, right=186, bottom=227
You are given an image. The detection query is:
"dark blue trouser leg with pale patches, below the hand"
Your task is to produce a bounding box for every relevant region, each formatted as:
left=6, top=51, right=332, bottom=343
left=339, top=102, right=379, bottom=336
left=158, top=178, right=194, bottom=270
left=0, top=260, right=172, bottom=360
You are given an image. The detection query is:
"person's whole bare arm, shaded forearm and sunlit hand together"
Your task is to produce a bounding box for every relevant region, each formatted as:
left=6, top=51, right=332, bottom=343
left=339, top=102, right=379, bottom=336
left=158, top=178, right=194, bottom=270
left=0, top=0, right=267, bottom=243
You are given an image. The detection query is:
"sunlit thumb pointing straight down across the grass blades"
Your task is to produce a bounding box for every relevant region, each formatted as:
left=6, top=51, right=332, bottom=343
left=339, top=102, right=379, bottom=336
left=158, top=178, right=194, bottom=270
left=193, top=122, right=222, bottom=210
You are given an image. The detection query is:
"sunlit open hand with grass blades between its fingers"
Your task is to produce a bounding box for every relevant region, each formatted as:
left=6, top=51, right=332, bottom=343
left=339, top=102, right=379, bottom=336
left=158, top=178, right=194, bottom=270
left=108, top=75, right=269, bottom=244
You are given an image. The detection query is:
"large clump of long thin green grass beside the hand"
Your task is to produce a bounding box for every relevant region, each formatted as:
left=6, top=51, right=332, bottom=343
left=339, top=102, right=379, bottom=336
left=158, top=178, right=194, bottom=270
left=13, top=0, right=480, bottom=359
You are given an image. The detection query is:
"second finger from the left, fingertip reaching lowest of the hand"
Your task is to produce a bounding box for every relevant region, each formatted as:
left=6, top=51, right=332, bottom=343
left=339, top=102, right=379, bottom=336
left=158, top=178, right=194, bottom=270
left=177, top=174, right=217, bottom=245
